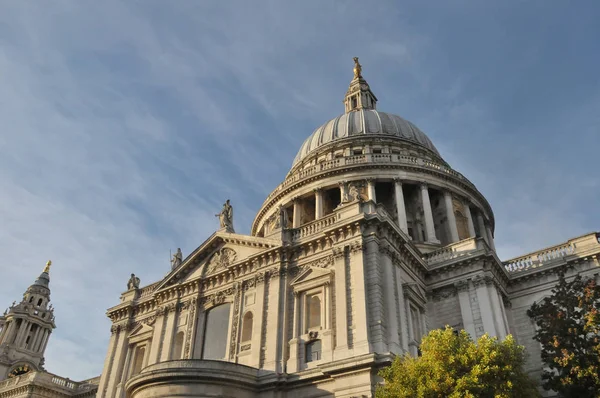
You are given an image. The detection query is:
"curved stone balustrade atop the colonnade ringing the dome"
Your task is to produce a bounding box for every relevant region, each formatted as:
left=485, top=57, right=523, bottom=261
left=265, top=153, right=474, bottom=203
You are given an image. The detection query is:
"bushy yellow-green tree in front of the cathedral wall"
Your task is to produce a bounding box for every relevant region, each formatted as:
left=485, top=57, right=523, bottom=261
left=375, top=326, right=540, bottom=398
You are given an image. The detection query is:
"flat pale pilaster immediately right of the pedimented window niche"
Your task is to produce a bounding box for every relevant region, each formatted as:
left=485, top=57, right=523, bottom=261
left=333, top=247, right=350, bottom=360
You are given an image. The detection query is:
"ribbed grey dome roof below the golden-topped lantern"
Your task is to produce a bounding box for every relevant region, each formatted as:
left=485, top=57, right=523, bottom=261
left=292, top=109, right=440, bottom=167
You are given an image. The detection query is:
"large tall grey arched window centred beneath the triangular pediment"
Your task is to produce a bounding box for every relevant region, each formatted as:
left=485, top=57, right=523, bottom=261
left=202, top=303, right=231, bottom=361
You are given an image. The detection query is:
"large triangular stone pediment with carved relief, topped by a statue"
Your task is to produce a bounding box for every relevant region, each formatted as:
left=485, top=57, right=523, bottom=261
left=157, top=231, right=281, bottom=290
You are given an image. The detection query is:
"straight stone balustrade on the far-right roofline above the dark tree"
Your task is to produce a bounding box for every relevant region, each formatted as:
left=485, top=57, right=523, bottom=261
left=502, top=233, right=600, bottom=272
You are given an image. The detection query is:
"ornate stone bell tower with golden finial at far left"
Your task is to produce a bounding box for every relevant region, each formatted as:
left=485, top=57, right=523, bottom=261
left=0, top=261, right=56, bottom=380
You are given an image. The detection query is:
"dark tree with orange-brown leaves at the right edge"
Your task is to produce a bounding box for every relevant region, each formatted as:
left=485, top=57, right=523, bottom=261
left=527, top=272, right=600, bottom=398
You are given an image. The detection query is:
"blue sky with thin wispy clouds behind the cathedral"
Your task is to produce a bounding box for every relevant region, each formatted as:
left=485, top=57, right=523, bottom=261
left=0, top=0, right=600, bottom=379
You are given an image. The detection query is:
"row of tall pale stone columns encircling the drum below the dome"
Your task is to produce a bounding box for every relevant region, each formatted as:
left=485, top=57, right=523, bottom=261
left=292, top=178, right=495, bottom=250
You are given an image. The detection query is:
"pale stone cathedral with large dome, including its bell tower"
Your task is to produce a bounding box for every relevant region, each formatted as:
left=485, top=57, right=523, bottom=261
left=0, top=58, right=600, bottom=398
